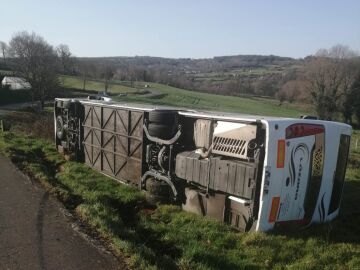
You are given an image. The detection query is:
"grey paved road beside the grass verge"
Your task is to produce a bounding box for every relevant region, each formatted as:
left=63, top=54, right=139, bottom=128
left=0, top=155, right=124, bottom=270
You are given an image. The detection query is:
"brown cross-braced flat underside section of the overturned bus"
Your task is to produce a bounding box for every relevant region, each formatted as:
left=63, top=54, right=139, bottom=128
left=83, top=104, right=144, bottom=185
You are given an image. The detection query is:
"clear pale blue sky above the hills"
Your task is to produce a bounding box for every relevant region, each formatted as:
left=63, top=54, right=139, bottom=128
left=0, top=0, right=360, bottom=58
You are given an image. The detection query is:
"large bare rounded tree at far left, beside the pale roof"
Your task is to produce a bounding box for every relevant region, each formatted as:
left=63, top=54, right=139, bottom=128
left=9, top=32, right=58, bottom=108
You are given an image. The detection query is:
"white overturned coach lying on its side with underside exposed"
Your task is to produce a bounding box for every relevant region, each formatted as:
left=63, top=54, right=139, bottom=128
left=54, top=98, right=351, bottom=231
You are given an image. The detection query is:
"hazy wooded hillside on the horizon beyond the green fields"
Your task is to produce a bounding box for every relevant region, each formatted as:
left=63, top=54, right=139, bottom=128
left=75, top=55, right=304, bottom=96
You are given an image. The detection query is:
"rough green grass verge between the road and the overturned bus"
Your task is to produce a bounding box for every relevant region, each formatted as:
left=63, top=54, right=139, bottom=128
left=0, top=110, right=360, bottom=269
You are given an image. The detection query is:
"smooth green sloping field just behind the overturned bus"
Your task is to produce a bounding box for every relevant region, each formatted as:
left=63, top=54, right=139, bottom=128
left=63, top=76, right=305, bottom=117
